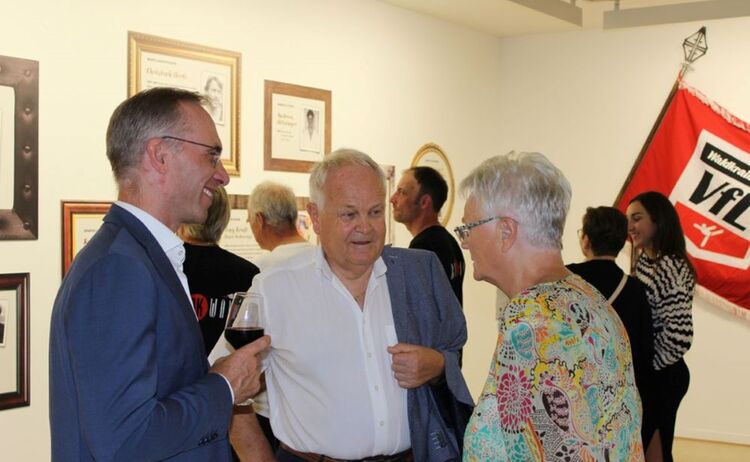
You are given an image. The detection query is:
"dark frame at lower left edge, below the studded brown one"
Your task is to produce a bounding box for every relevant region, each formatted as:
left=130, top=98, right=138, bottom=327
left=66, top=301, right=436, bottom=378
left=0, top=273, right=31, bottom=409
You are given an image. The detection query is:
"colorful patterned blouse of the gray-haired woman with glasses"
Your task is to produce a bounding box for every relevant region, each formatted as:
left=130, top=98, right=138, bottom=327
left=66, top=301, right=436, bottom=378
left=463, top=275, right=643, bottom=461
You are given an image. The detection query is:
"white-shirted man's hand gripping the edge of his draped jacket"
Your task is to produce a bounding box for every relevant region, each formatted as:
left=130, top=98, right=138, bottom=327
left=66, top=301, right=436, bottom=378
left=388, top=343, right=445, bottom=388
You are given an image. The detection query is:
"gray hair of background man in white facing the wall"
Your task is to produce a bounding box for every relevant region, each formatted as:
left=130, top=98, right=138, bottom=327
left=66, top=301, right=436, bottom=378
left=247, top=181, right=297, bottom=231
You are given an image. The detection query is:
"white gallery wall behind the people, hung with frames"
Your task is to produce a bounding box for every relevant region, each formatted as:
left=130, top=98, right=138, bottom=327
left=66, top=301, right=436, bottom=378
left=0, top=0, right=750, bottom=461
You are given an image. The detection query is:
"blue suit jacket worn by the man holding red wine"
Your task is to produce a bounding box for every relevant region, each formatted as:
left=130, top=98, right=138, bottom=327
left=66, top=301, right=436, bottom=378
left=49, top=205, right=232, bottom=462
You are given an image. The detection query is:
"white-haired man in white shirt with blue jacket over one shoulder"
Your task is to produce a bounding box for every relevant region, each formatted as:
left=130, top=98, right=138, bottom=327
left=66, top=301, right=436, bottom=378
left=232, top=149, right=473, bottom=462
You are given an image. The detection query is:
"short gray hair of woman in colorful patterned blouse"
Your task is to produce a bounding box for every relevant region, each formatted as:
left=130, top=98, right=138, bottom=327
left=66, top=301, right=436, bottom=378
left=460, top=151, right=572, bottom=249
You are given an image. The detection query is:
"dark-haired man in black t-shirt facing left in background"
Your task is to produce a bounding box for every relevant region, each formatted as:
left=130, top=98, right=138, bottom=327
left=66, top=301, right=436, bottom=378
left=390, top=167, right=465, bottom=305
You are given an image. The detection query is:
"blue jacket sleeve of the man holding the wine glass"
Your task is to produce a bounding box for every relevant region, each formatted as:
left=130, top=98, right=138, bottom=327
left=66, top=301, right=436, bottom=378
left=64, top=254, right=232, bottom=461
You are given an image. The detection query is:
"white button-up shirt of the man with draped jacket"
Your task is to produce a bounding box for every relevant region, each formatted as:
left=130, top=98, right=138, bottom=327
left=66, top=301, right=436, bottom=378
left=258, top=247, right=411, bottom=459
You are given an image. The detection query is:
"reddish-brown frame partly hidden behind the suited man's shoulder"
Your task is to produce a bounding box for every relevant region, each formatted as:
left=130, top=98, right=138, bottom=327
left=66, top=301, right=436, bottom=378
left=61, top=201, right=112, bottom=276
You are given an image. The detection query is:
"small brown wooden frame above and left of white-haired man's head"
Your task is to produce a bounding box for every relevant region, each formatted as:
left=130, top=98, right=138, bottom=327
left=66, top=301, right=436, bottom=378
left=263, top=80, right=331, bottom=173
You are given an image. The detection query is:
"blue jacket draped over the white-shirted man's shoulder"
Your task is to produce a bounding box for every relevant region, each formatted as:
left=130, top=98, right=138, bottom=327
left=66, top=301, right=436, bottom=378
left=382, top=247, right=474, bottom=462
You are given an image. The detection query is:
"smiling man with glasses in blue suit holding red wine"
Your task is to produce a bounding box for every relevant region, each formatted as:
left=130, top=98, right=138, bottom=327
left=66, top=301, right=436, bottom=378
left=50, top=88, right=270, bottom=462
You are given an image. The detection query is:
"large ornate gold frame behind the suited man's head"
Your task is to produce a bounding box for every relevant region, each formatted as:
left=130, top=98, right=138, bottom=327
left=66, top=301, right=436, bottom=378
left=128, top=32, right=242, bottom=175
